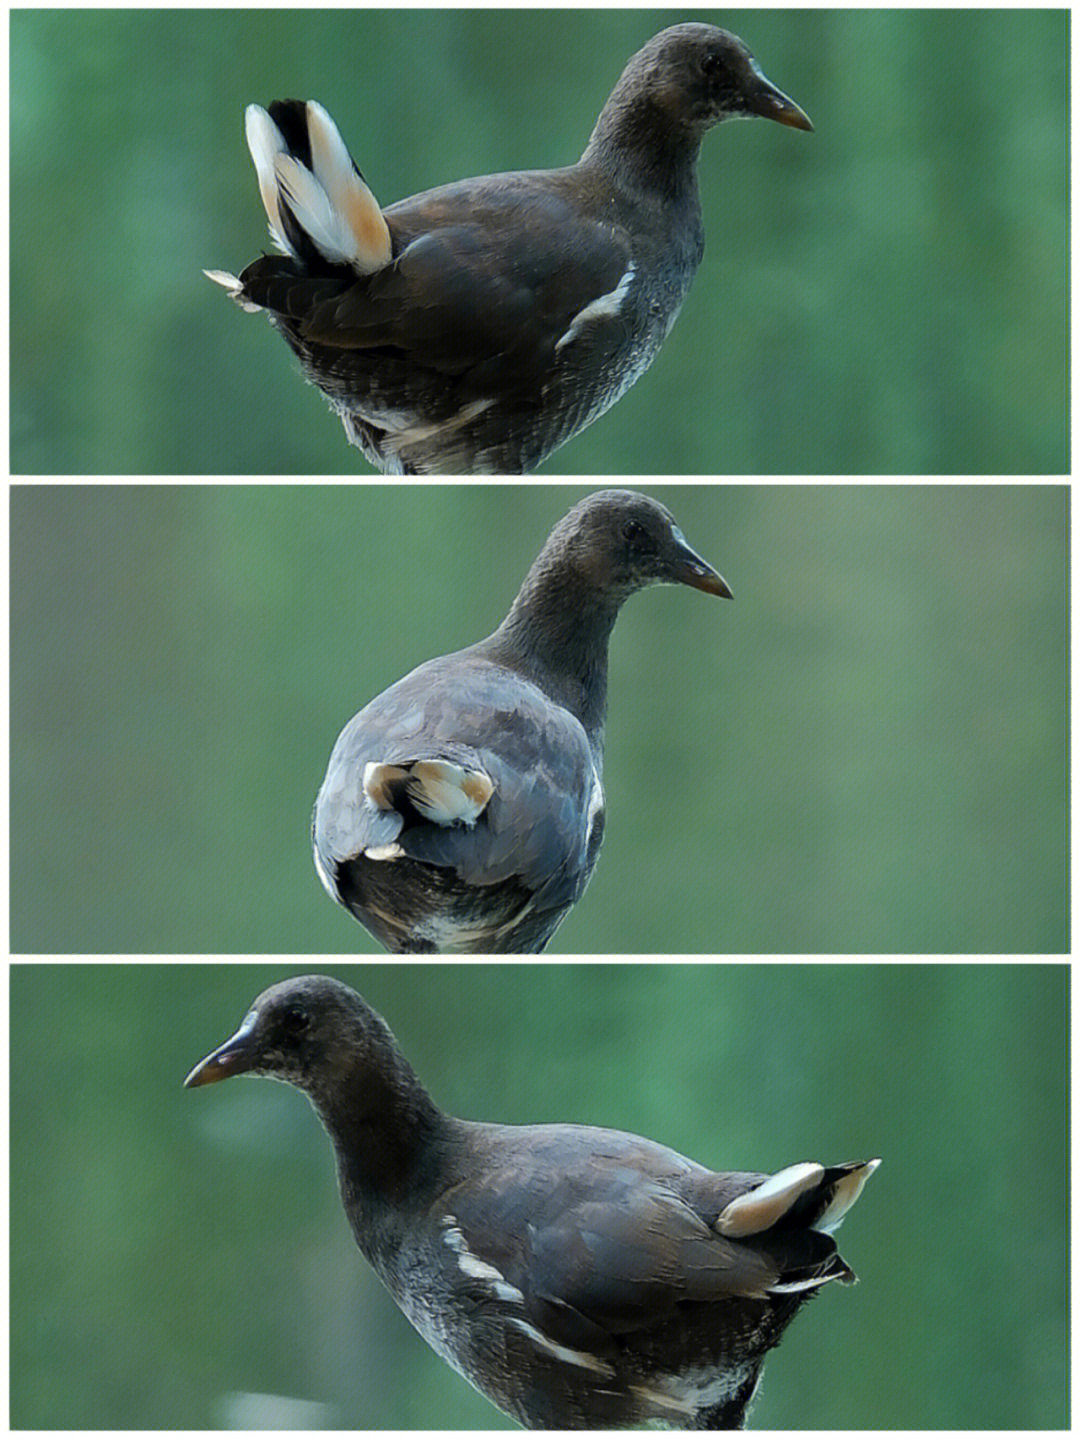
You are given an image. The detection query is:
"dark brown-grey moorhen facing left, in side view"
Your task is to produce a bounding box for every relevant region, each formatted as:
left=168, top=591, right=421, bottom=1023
left=186, top=974, right=880, bottom=1429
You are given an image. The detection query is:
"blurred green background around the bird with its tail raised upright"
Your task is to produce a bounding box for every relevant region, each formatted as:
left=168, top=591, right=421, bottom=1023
left=10, top=7, right=1068, bottom=475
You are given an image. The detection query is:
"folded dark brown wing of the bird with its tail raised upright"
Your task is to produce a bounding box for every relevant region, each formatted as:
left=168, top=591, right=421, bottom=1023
left=242, top=171, right=633, bottom=394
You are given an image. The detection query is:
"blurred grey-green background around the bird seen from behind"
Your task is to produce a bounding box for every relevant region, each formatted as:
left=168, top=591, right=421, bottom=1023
left=10, top=485, right=1067, bottom=954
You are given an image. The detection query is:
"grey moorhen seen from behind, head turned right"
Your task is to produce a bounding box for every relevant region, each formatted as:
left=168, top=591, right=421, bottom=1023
left=312, top=489, right=732, bottom=954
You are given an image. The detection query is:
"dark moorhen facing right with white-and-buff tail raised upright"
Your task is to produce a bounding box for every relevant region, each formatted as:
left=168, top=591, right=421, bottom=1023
left=206, top=24, right=814, bottom=475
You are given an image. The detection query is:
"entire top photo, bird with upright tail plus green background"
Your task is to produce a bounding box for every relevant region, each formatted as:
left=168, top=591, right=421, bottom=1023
left=10, top=7, right=1068, bottom=476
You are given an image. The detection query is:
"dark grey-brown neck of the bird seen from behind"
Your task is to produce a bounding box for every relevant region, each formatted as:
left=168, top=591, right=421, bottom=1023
left=485, top=555, right=624, bottom=755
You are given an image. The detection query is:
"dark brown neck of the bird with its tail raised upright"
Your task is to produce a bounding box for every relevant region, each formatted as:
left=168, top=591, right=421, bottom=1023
left=581, top=85, right=702, bottom=205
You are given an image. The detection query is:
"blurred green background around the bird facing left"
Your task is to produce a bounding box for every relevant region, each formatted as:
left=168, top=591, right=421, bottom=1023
left=10, top=961, right=1068, bottom=1430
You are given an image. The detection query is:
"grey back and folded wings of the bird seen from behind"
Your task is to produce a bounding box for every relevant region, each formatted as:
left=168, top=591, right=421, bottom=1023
left=314, top=655, right=603, bottom=905
